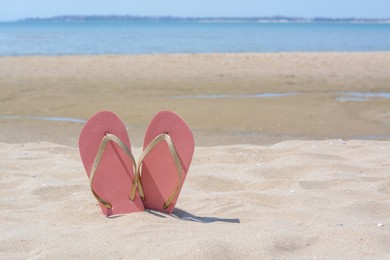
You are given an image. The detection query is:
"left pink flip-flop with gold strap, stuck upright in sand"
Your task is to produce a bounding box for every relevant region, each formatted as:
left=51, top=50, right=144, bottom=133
left=79, top=111, right=144, bottom=216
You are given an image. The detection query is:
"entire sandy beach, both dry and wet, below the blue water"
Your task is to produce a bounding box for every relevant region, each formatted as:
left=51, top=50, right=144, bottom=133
left=0, top=52, right=390, bottom=259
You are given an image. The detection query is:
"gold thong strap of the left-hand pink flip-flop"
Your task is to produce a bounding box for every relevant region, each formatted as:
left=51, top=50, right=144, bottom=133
left=89, top=134, right=136, bottom=209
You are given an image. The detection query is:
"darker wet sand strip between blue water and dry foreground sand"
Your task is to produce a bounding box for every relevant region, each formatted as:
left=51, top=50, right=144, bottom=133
left=0, top=52, right=390, bottom=147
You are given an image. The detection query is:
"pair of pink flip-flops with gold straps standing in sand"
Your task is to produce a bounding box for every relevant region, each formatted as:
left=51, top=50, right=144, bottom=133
left=79, top=111, right=195, bottom=216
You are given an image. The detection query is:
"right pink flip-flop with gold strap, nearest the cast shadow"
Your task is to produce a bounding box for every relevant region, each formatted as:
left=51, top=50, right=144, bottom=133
left=137, top=111, right=195, bottom=213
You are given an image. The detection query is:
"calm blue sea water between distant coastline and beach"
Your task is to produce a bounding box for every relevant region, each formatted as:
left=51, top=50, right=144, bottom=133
left=0, top=21, right=390, bottom=56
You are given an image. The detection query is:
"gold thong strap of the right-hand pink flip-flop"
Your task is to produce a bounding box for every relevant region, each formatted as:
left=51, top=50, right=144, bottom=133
left=136, top=133, right=183, bottom=209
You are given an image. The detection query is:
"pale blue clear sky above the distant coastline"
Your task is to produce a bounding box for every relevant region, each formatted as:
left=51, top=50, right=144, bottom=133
left=0, top=0, right=390, bottom=21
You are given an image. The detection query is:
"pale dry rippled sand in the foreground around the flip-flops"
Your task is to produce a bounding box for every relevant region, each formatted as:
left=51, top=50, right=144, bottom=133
left=0, top=140, right=390, bottom=259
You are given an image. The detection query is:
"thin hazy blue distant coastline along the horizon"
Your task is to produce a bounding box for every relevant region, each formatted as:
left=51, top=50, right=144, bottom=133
left=18, top=15, right=390, bottom=23
